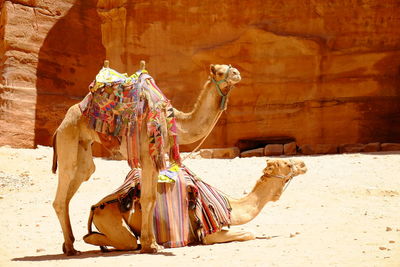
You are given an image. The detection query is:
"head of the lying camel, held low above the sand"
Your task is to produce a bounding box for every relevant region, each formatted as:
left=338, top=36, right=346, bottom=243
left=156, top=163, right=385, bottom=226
left=261, top=159, right=307, bottom=201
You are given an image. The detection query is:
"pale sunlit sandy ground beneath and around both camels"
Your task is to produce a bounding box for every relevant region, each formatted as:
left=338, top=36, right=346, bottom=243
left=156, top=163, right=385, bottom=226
left=0, top=147, right=400, bottom=267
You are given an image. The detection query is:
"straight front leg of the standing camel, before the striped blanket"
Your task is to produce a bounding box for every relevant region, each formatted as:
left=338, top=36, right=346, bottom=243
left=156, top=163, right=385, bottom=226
left=140, top=161, right=162, bottom=253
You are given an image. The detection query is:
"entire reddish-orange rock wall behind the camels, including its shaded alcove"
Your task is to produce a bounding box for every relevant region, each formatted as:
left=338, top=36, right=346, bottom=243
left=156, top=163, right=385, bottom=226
left=0, top=0, right=400, bottom=154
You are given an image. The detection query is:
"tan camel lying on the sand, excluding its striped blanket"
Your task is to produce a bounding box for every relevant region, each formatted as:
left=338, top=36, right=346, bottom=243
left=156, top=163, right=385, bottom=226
left=84, top=159, right=307, bottom=250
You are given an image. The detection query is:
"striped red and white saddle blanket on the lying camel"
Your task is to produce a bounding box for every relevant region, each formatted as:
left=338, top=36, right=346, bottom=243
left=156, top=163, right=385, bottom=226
left=102, top=165, right=231, bottom=248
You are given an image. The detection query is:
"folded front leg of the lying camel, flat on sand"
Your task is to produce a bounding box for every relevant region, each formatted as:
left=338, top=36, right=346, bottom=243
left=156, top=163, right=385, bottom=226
left=203, top=229, right=256, bottom=245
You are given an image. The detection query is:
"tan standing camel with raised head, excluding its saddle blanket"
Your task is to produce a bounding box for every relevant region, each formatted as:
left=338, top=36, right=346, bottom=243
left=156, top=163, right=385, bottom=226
left=52, top=62, right=241, bottom=255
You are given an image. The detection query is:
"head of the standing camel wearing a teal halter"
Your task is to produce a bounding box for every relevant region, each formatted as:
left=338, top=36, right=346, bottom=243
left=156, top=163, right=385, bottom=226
left=210, top=64, right=242, bottom=89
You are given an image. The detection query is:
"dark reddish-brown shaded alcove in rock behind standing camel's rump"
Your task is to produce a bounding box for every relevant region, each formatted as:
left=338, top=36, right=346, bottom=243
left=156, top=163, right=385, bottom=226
left=35, top=0, right=105, bottom=149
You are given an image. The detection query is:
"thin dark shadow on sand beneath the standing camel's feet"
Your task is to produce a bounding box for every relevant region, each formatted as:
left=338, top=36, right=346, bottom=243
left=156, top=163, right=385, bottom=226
left=11, top=250, right=176, bottom=261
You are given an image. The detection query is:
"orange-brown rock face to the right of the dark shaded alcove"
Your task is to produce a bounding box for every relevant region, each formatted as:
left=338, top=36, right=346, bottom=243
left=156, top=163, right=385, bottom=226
left=101, top=0, right=400, bottom=151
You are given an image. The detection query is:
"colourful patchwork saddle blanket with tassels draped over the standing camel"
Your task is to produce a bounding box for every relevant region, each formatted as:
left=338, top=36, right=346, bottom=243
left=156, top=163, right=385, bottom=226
left=79, top=67, right=180, bottom=170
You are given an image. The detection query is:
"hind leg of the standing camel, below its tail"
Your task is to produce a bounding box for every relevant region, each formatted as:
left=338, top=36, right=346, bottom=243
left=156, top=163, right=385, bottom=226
left=53, top=119, right=95, bottom=255
